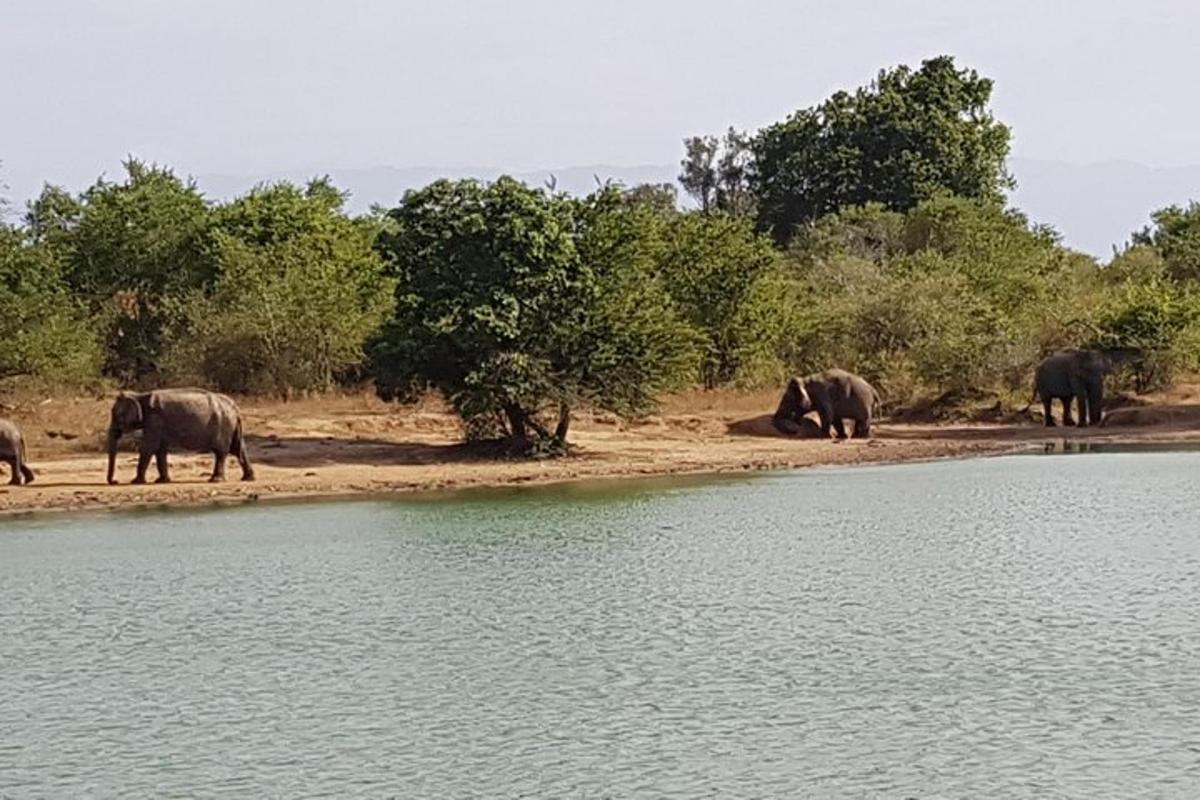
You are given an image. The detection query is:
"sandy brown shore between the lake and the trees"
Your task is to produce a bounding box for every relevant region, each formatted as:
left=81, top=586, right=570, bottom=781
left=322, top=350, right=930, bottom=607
left=0, top=393, right=1200, bottom=515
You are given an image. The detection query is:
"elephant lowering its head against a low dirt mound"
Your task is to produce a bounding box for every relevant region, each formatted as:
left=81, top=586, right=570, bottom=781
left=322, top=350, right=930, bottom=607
left=774, top=369, right=880, bottom=439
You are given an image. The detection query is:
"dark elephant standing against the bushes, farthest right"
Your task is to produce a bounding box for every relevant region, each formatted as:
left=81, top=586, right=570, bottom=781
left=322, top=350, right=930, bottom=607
left=1031, top=350, right=1135, bottom=428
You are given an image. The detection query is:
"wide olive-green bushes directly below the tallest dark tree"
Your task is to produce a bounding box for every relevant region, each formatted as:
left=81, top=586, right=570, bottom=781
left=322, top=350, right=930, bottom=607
left=788, top=197, right=1100, bottom=404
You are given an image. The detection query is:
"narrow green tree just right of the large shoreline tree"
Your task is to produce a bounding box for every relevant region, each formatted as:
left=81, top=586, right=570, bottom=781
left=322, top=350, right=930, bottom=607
left=660, top=213, right=778, bottom=387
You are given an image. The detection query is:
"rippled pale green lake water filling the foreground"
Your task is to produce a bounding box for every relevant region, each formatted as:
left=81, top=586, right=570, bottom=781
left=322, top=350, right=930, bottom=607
left=0, top=452, right=1200, bottom=799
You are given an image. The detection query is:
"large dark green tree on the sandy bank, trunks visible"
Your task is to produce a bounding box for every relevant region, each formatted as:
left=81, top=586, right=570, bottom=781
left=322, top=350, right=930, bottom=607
left=372, top=178, right=692, bottom=451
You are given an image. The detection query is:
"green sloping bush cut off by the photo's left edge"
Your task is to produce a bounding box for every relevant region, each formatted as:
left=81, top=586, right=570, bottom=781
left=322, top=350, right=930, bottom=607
left=0, top=224, right=100, bottom=383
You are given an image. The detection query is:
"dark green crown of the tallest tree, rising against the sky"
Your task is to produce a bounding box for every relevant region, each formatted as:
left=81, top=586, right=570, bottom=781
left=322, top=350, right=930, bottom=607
left=752, top=56, right=1013, bottom=241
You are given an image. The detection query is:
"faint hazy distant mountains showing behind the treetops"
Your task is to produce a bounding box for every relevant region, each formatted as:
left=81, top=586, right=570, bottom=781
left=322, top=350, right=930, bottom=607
left=60, top=158, right=1200, bottom=259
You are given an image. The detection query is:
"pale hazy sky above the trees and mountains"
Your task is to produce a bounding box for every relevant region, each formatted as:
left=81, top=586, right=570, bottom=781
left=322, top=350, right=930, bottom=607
left=0, top=0, right=1200, bottom=198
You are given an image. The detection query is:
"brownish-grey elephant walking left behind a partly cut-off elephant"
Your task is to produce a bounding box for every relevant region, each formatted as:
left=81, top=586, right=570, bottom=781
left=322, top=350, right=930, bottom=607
left=108, top=389, right=254, bottom=483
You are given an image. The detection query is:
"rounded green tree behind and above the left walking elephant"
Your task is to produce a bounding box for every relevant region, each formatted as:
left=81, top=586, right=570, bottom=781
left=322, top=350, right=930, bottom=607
left=170, top=180, right=395, bottom=395
